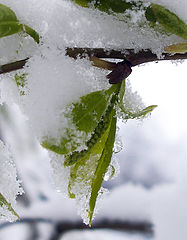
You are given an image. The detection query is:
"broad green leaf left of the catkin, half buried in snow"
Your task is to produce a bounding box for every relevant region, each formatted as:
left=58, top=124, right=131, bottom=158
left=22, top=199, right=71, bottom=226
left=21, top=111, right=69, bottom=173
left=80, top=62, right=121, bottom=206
left=42, top=84, right=119, bottom=155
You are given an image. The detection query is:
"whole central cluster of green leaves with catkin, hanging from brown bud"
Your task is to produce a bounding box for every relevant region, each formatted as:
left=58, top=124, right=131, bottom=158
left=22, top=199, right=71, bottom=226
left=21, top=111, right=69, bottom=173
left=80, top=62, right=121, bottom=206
left=42, top=80, right=156, bottom=225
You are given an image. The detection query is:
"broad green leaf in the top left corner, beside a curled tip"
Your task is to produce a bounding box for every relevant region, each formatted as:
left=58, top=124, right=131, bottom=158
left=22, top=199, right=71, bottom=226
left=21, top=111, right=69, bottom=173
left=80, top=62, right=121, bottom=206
left=0, top=4, right=22, bottom=38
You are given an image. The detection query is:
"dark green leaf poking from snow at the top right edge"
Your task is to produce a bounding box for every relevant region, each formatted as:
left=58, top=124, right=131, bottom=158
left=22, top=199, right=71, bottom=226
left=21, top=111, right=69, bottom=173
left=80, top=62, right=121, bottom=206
left=145, top=3, right=187, bottom=39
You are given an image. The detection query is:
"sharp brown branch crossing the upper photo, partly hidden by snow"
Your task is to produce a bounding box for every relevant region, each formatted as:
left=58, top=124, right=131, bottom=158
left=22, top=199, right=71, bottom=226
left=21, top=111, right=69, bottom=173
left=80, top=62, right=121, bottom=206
left=0, top=48, right=187, bottom=74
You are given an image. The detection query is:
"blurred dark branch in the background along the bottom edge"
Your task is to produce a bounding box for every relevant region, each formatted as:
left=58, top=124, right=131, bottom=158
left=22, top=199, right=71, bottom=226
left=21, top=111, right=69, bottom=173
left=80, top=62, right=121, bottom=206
left=0, top=218, right=154, bottom=240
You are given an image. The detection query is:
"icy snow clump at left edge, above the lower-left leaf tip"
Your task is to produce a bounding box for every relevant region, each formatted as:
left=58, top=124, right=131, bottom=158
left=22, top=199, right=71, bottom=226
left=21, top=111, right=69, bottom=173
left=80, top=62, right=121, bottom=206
left=0, top=141, right=23, bottom=221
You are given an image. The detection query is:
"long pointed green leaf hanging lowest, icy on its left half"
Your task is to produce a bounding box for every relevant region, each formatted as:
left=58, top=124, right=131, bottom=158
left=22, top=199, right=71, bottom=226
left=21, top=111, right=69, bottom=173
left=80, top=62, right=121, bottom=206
left=69, top=96, right=116, bottom=224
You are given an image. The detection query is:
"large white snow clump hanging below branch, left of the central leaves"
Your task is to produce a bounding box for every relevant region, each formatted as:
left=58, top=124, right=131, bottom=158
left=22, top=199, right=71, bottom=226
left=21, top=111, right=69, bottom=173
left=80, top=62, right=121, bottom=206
left=22, top=47, right=107, bottom=141
